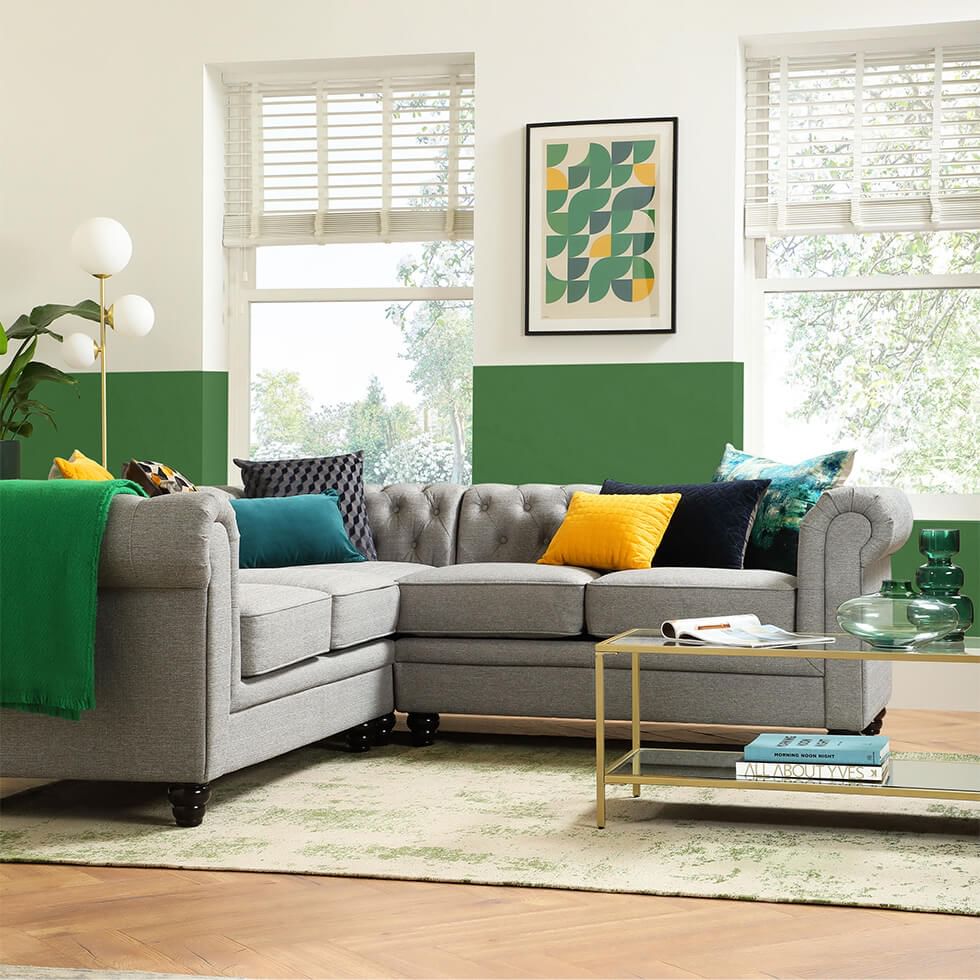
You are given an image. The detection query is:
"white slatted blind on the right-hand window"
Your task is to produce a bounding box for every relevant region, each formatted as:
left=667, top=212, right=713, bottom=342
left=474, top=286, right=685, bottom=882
left=745, top=42, right=980, bottom=237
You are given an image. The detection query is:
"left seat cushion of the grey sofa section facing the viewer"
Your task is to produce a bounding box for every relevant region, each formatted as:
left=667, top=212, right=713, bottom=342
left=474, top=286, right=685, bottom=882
left=398, top=562, right=598, bottom=637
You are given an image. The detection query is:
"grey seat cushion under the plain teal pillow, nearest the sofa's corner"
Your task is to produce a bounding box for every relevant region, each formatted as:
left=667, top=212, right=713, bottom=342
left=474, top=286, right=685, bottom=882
left=239, top=561, right=428, bottom=653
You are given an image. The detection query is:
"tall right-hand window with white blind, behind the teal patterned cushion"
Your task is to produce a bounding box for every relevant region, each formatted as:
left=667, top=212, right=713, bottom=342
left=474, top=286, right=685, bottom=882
left=745, top=41, right=980, bottom=517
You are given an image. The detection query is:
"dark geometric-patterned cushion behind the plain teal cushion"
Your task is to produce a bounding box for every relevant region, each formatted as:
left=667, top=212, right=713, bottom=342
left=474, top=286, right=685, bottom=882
left=235, top=452, right=378, bottom=561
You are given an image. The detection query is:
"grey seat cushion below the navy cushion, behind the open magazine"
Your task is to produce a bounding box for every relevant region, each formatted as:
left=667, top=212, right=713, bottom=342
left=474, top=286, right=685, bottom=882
left=585, top=568, right=796, bottom=636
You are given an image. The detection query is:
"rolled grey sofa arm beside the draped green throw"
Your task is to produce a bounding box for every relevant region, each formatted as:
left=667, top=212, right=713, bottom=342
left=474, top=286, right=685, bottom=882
left=99, top=490, right=238, bottom=589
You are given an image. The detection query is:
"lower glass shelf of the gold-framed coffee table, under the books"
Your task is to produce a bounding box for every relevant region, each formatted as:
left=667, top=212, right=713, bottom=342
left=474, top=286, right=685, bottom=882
left=607, top=748, right=980, bottom=799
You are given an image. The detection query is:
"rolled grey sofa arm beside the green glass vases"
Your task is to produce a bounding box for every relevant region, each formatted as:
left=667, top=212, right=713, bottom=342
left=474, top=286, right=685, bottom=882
left=796, top=487, right=912, bottom=633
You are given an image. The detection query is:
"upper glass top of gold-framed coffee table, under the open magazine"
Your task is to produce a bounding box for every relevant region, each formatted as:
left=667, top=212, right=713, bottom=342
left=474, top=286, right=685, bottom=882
left=595, top=629, right=980, bottom=663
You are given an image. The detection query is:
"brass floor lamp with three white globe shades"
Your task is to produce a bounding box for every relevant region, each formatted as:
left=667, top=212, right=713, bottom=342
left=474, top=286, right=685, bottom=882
left=64, top=218, right=153, bottom=469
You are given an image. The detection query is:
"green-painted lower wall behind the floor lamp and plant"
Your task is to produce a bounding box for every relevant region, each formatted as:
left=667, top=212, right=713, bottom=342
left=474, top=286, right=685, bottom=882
left=21, top=371, right=228, bottom=483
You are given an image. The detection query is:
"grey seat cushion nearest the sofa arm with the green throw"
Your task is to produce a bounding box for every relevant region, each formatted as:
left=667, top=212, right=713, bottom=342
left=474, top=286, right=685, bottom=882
left=239, top=583, right=331, bottom=677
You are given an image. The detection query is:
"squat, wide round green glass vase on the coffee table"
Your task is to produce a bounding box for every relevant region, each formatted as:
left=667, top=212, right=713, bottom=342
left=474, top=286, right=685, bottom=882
left=837, top=595, right=959, bottom=650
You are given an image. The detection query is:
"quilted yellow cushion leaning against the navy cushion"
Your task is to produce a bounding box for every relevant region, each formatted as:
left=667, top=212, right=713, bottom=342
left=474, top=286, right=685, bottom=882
left=538, top=491, right=681, bottom=571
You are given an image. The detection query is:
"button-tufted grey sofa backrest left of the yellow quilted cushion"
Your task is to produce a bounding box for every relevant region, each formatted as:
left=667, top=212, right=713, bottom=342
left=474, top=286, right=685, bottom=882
left=365, top=483, right=599, bottom=566
